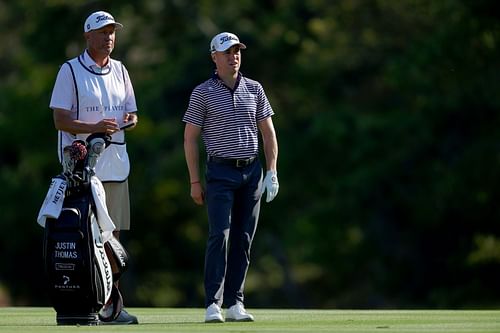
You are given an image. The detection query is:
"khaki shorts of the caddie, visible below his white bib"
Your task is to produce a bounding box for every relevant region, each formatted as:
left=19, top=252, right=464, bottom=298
left=102, top=180, right=130, bottom=231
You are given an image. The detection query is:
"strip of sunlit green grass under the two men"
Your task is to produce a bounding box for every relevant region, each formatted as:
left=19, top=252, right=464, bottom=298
left=0, top=307, right=500, bottom=333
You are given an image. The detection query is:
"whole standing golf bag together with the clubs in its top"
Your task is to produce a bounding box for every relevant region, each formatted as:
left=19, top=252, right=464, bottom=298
left=44, top=135, right=128, bottom=325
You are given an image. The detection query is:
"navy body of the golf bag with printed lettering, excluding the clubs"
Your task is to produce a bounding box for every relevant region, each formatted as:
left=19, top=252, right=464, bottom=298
left=44, top=183, right=113, bottom=325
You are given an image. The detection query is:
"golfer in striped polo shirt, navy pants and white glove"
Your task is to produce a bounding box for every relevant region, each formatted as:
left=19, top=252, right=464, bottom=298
left=183, top=32, right=279, bottom=322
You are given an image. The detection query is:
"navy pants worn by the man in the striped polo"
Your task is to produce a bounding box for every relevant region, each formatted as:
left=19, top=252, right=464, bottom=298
left=205, top=159, right=262, bottom=307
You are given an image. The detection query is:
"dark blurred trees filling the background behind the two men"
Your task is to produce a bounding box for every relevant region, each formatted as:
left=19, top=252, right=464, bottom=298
left=0, top=0, right=500, bottom=308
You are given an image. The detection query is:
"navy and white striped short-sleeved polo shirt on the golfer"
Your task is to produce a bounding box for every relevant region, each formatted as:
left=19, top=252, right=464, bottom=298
left=182, top=74, right=274, bottom=158
